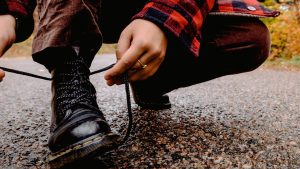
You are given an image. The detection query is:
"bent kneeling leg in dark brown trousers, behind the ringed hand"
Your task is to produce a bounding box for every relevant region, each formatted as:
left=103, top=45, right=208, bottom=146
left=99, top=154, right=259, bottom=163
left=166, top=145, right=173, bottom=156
left=134, top=16, right=270, bottom=108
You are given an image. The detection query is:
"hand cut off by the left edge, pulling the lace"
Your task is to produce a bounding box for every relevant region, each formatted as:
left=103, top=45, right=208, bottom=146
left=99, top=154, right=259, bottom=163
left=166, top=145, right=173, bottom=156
left=0, top=15, right=16, bottom=82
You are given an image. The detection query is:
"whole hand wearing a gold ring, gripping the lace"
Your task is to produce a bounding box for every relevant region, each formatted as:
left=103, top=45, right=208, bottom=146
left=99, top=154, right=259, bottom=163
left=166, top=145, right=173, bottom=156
left=104, top=19, right=168, bottom=86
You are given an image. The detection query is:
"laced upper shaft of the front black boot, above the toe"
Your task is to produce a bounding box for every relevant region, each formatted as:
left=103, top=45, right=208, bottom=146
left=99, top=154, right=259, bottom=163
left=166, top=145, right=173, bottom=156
left=51, top=52, right=101, bottom=132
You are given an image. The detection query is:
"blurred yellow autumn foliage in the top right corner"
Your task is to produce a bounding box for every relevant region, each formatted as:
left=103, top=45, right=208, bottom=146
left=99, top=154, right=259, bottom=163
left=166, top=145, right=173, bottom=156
left=262, top=0, right=300, bottom=60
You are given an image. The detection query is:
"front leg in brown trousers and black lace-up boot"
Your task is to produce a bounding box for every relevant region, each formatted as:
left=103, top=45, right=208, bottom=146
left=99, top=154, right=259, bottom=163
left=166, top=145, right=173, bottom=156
left=33, top=0, right=120, bottom=168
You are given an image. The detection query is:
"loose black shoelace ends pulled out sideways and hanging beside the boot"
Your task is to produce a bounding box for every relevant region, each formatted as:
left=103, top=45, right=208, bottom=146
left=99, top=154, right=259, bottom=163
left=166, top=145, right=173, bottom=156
left=0, top=64, right=132, bottom=144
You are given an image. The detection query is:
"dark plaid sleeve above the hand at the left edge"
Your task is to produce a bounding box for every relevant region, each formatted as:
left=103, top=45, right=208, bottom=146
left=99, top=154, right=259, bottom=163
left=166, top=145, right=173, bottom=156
left=0, top=0, right=36, bottom=42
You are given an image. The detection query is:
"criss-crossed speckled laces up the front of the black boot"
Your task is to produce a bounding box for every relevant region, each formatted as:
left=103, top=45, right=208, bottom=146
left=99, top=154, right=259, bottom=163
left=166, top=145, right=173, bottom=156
left=54, top=59, right=99, bottom=118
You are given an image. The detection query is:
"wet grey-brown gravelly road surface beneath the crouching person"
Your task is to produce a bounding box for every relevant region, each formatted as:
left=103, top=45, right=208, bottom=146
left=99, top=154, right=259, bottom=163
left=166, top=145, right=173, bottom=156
left=0, top=55, right=300, bottom=169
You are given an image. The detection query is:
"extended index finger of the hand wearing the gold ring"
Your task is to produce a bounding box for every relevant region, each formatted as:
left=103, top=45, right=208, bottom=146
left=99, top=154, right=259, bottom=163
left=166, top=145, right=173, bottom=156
left=104, top=45, right=145, bottom=80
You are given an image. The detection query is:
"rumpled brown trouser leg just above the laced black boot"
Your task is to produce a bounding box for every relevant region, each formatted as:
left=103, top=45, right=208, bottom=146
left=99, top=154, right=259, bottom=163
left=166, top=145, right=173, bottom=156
left=32, top=0, right=102, bottom=70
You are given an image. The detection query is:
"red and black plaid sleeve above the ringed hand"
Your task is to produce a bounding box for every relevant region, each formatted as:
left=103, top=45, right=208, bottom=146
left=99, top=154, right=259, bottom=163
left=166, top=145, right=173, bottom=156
left=133, top=0, right=215, bottom=57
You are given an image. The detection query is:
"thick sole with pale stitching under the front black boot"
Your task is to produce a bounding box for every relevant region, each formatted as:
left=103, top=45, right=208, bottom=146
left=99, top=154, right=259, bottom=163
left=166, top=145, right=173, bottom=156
left=49, top=133, right=121, bottom=169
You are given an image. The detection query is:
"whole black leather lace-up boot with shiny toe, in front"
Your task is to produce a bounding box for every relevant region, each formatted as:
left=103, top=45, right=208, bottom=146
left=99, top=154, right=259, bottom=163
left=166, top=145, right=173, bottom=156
left=48, top=52, right=120, bottom=168
